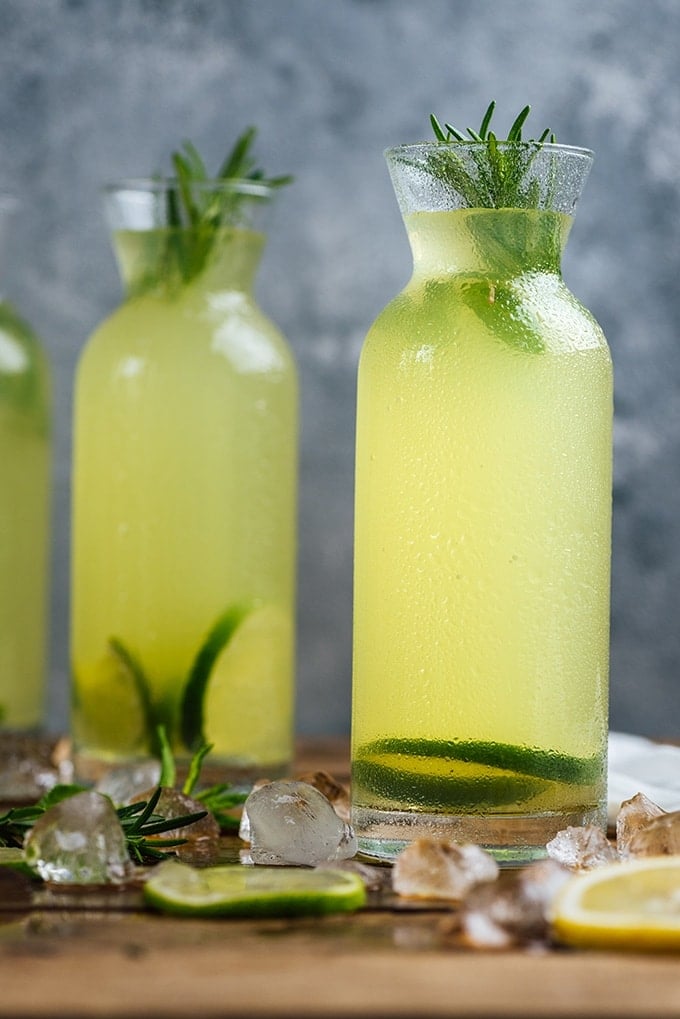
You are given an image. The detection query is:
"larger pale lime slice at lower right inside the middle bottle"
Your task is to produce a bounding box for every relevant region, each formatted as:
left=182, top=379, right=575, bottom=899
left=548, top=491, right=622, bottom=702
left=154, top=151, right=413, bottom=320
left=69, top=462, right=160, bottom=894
left=199, top=605, right=293, bottom=762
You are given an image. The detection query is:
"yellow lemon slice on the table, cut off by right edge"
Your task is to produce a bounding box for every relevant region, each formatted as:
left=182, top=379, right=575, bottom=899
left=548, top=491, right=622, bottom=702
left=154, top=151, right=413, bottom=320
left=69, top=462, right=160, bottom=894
left=551, top=856, right=680, bottom=951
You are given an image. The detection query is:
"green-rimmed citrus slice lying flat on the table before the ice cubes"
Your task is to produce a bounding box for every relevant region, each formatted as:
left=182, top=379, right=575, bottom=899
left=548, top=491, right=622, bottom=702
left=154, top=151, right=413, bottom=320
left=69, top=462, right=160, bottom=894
left=144, top=860, right=366, bottom=916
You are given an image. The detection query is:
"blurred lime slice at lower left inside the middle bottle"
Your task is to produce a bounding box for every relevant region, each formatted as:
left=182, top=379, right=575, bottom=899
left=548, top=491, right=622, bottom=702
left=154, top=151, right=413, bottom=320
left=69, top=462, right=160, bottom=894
left=73, top=638, right=153, bottom=755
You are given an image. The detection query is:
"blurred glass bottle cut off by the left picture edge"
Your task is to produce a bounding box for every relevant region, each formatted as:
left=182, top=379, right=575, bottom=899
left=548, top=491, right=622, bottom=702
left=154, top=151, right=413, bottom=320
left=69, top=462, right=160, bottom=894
left=0, top=196, right=51, bottom=732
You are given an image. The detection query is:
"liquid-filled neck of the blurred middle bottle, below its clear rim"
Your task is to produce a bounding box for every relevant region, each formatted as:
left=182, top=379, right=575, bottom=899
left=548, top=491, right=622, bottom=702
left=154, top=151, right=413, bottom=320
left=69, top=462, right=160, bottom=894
left=113, top=227, right=265, bottom=297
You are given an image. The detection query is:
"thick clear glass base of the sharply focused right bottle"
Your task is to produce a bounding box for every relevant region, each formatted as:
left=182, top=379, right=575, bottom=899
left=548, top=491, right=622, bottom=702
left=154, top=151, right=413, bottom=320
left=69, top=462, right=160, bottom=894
left=352, top=805, right=606, bottom=867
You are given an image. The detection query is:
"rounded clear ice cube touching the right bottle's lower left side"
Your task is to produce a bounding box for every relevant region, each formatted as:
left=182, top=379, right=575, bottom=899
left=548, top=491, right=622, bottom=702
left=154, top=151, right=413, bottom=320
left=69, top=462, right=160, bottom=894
left=244, top=782, right=357, bottom=867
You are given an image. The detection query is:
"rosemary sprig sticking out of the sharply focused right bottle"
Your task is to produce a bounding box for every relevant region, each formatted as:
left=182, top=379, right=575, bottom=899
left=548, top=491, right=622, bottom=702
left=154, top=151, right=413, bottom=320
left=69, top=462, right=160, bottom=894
left=428, top=100, right=556, bottom=209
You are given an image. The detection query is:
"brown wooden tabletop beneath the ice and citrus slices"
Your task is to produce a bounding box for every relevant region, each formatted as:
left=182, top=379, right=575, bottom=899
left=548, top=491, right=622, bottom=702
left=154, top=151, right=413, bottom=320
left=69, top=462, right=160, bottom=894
left=0, top=741, right=680, bottom=1019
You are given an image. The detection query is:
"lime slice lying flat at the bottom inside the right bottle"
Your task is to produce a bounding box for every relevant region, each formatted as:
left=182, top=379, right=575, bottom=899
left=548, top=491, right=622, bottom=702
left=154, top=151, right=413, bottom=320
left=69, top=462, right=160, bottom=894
left=352, top=738, right=601, bottom=810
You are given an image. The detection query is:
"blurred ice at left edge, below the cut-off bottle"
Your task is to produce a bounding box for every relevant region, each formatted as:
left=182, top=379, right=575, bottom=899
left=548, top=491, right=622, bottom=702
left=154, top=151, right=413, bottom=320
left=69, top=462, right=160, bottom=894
left=0, top=733, right=73, bottom=803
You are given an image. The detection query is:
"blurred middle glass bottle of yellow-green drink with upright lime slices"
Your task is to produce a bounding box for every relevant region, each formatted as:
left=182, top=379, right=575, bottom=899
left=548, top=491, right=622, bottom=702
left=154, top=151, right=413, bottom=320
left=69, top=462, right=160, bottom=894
left=71, top=180, right=297, bottom=779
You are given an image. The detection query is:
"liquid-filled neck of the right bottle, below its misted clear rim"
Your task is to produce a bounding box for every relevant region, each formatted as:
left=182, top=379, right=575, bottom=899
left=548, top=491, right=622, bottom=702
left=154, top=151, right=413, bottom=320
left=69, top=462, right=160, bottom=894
left=404, top=209, right=572, bottom=279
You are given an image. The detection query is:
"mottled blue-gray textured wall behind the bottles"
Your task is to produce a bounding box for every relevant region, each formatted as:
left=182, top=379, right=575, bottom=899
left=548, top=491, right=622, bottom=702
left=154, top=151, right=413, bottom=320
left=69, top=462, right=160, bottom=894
left=0, top=0, right=680, bottom=737
